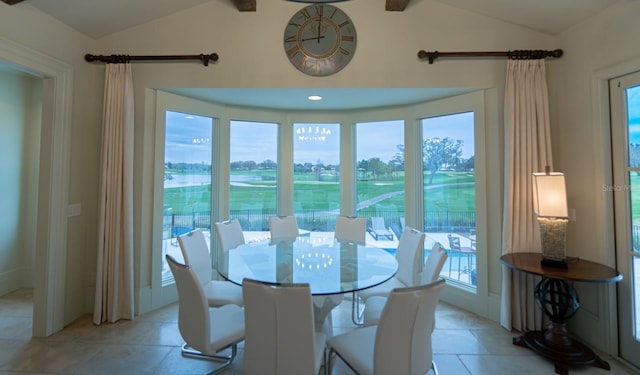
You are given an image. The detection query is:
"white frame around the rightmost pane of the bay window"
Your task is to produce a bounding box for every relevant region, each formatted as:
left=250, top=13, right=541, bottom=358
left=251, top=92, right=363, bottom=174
left=405, top=90, right=496, bottom=316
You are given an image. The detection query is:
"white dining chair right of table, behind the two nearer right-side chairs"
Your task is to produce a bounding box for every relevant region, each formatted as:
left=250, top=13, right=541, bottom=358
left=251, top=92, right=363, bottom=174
left=351, top=226, right=424, bottom=325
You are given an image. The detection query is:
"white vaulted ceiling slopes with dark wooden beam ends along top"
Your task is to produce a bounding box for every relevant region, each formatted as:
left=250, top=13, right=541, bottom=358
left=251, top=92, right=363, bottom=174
left=1, top=0, right=638, bottom=39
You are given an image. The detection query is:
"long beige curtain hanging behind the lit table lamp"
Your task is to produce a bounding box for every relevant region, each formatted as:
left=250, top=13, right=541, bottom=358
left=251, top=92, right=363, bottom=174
left=500, top=59, right=553, bottom=331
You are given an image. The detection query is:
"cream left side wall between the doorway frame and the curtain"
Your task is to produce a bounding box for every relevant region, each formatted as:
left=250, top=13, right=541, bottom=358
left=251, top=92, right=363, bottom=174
left=0, top=2, right=102, bottom=326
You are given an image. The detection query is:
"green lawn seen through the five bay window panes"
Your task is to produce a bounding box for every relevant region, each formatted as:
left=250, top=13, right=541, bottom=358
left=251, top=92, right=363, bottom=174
left=164, top=170, right=476, bottom=214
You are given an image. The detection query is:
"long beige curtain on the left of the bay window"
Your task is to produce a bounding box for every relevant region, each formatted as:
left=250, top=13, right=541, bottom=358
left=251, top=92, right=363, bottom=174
left=93, top=63, right=134, bottom=324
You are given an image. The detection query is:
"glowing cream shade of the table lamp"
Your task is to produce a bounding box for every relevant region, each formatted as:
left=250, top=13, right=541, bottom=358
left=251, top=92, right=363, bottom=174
left=532, top=172, right=568, bottom=218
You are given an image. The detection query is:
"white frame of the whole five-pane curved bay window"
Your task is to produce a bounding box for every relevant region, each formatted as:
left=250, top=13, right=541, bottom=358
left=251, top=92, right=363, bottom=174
left=151, top=89, right=503, bottom=316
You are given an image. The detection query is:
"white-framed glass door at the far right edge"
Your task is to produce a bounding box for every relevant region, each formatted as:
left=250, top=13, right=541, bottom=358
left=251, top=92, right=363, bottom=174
left=606, top=72, right=640, bottom=367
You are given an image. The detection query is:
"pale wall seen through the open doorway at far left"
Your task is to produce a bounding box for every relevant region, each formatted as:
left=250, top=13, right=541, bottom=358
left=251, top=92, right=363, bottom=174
left=0, top=67, right=42, bottom=295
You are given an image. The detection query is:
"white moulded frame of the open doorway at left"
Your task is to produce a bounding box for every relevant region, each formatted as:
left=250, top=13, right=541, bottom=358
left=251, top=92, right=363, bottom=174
left=0, top=37, right=73, bottom=337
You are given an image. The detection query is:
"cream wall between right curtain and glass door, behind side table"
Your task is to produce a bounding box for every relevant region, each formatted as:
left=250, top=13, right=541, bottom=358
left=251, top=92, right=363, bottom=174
left=549, top=1, right=640, bottom=352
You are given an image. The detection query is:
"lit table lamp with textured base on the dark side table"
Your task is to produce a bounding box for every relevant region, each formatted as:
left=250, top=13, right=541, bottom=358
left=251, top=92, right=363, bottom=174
left=532, top=166, right=568, bottom=268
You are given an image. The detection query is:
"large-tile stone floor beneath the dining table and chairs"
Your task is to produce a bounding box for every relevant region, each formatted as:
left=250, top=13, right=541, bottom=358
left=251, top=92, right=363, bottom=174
left=0, top=290, right=637, bottom=375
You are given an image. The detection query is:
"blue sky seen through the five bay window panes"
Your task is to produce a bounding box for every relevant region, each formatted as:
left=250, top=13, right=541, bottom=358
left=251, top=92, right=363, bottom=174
left=165, top=111, right=474, bottom=165
